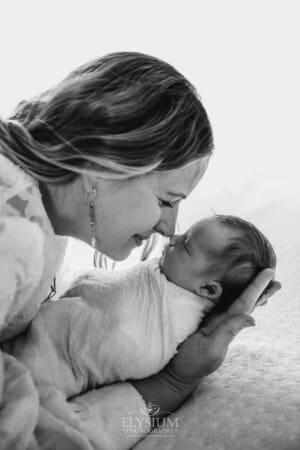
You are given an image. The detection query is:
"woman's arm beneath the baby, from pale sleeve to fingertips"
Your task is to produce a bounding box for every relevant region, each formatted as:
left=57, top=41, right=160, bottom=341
left=61, top=270, right=274, bottom=450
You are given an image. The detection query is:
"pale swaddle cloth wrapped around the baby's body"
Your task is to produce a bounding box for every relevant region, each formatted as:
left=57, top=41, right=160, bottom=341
left=5, top=259, right=213, bottom=398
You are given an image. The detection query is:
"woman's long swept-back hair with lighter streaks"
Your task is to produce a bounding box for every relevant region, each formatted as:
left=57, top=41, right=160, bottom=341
left=0, top=52, right=213, bottom=183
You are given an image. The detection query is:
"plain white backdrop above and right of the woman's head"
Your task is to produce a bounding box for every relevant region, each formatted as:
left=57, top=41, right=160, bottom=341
left=0, top=0, right=300, bottom=274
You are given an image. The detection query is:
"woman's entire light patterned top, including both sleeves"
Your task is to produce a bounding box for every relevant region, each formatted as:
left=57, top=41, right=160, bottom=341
left=0, top=149, right=150, bottom=450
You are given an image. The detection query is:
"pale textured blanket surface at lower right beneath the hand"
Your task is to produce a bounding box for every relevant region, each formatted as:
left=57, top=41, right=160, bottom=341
left=135, top=183, right=300, bottom=450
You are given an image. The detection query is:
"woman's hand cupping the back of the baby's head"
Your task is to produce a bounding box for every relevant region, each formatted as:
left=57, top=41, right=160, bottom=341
left=165, top=269, right=281, bottom=386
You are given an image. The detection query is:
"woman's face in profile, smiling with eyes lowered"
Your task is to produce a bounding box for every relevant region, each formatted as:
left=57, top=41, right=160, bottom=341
left=94, top=157, right=209, bottom=260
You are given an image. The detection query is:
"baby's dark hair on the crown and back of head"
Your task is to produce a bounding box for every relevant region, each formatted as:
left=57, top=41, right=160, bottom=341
left=212, top=214, right=276, bottom=311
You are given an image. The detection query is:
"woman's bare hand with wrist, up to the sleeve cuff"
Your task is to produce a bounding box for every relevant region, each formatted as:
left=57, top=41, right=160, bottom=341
left=132, top=269, right=280, bottom=415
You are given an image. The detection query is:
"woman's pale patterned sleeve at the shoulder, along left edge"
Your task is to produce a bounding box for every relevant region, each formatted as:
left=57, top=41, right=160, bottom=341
left=0, top=154, right=66, bottom=340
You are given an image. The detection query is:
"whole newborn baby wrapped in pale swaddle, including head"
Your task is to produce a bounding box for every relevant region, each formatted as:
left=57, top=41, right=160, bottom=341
left=4, top=215, right=276, bottom=398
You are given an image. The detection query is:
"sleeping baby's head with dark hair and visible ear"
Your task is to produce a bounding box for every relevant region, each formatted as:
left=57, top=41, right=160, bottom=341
left=160, top=215, right=276, bottom=310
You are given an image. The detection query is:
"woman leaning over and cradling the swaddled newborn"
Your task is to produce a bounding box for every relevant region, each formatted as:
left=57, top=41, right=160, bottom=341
left=0, top=52, right=277, bottom=449
